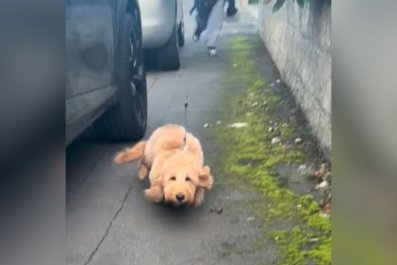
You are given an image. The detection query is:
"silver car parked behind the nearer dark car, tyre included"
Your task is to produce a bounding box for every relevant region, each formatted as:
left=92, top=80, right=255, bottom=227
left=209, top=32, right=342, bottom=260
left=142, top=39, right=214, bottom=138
left=139, top=0, right=185, bottom=70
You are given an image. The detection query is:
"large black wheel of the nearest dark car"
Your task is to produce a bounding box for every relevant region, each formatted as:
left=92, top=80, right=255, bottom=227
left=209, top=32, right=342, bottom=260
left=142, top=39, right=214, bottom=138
left=95, top=13, right=147, bottom=141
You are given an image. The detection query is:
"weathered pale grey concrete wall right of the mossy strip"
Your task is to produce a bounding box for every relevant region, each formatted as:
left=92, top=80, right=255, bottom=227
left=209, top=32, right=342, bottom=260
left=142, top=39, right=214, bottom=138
left=258, top=0, right=331, bottom=155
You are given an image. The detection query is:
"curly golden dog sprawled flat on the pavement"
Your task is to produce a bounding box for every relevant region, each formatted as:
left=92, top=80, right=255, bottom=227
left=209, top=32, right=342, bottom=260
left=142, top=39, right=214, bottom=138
left=114, top=124, right=213, bottom=206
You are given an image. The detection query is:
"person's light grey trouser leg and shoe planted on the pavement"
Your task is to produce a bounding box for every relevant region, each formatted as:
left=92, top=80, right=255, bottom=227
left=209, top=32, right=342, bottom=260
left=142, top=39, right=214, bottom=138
left=206, top=0, right=224, bottom=55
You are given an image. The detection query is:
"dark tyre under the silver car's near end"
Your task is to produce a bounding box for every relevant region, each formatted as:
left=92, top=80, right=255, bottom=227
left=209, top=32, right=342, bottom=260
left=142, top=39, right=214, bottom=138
left=157, top=27, right=180, bottom=71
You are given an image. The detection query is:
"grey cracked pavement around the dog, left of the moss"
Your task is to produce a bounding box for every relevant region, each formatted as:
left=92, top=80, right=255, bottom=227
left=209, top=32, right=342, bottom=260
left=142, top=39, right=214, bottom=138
left=66, top=2, right=274, bottom=265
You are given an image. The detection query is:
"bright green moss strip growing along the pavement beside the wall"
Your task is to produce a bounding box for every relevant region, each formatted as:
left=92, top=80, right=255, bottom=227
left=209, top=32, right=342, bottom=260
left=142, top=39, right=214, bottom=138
left=212, top=37, right=331, bottom=265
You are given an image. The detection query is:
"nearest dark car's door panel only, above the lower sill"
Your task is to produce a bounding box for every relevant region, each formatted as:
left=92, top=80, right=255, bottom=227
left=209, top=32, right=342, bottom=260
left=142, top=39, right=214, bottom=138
left=65, top=0, right=115, bottom=98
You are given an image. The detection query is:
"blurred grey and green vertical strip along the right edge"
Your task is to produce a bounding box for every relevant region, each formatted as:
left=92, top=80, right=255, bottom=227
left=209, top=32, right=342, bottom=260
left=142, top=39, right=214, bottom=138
left=332, top=0, right=397, bottom=264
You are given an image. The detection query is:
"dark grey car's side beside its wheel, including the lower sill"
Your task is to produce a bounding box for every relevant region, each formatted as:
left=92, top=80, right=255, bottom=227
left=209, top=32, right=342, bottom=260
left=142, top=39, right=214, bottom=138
left=65, top=0, right=117, bottom=142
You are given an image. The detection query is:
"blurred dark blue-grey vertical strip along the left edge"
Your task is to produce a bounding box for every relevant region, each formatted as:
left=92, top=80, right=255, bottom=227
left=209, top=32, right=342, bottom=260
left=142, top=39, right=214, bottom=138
left=0, top=0, right=65, bottom=265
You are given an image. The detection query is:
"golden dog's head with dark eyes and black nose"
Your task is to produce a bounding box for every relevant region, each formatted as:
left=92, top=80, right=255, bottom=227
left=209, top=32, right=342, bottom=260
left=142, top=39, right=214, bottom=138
left=163, top=152, right=213, bottom=206
